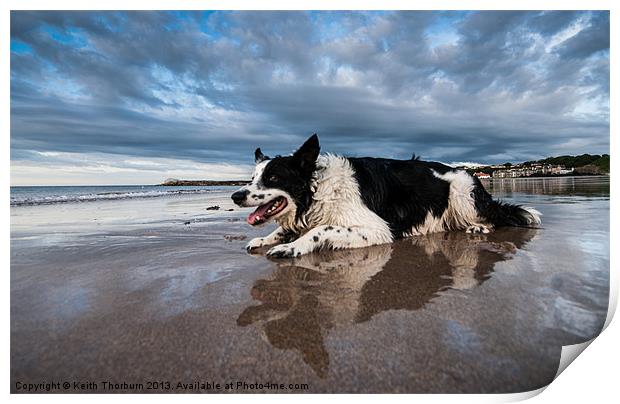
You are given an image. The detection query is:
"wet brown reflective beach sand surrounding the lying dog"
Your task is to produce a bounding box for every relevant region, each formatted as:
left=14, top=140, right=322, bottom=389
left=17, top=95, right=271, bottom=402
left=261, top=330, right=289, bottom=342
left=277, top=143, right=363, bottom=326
left=11, top=177, right=609, bottom=393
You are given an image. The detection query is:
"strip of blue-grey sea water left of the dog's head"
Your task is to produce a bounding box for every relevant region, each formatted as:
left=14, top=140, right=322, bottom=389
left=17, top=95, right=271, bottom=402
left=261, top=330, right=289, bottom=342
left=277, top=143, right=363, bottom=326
left=11, top=185, right=234, bottom=206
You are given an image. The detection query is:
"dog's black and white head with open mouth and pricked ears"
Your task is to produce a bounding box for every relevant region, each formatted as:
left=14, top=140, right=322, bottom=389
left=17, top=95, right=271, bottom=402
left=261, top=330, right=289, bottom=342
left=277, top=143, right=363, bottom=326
left=232, top=134, right=320, bottom=226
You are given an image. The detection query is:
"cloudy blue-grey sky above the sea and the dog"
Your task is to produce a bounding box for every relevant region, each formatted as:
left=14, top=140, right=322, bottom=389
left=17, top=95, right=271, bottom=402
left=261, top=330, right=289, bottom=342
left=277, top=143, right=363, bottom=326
left=11, top=11, right=609, bottom=185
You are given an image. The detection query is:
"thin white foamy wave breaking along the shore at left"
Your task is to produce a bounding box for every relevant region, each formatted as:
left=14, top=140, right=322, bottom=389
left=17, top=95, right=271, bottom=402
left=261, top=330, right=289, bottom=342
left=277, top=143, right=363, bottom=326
left=11, top=189, right=217, bottom=206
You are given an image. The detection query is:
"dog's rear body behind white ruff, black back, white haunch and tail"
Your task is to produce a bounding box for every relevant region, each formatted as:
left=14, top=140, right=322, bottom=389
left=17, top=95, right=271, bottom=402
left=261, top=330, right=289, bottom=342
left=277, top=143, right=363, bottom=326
left=348, top=157, right=540, bottom=238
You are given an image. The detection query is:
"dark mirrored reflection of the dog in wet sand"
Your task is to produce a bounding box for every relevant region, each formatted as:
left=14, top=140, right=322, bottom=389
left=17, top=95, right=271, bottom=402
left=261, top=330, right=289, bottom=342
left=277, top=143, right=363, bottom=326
left=237, top=229, right=535, bottom=377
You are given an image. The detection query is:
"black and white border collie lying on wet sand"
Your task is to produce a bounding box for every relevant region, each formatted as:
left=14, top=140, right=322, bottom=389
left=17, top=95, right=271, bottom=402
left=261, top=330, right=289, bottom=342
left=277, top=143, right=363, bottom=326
left=232, top=134, right=541, bottom=257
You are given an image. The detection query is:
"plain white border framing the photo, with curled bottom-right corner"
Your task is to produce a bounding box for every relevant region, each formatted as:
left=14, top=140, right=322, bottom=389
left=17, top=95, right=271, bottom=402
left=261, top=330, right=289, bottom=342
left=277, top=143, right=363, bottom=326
left=0, top=0, right=620, bottom=403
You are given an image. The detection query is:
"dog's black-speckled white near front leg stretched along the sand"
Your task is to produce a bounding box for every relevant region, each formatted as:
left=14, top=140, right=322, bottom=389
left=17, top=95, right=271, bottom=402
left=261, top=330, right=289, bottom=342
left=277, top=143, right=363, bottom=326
left=267, top=225, right=392, bottom=257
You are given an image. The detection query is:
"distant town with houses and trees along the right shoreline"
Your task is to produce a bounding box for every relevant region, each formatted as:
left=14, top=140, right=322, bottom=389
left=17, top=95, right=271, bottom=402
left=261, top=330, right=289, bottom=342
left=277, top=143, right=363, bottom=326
left=460, top=154, right=609, bottom=179
